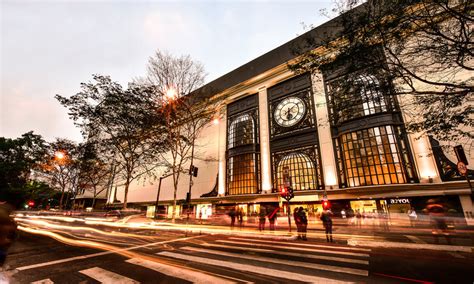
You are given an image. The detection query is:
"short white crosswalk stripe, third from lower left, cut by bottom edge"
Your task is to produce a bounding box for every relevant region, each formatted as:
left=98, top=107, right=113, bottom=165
left=127, top=258, right=237, bottom=284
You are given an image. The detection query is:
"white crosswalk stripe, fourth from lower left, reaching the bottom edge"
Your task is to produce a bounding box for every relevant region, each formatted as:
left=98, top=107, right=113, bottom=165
left=158, top=252, right=351, bottom=283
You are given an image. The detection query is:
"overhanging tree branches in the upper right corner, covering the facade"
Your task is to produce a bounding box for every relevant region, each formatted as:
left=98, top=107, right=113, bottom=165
left=289, top=0, right=474, bottom=141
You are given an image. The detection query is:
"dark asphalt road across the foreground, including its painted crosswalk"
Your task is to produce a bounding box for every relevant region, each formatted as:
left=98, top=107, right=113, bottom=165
left=6, top=227, right=474, bottom=283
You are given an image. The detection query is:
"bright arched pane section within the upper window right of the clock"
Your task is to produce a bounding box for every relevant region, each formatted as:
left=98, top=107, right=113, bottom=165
left=354, top=75, right=387, bottom=115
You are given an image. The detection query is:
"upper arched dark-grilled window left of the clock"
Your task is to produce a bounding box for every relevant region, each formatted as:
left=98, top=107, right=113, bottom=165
left=229, top=114, right=255, bottom=149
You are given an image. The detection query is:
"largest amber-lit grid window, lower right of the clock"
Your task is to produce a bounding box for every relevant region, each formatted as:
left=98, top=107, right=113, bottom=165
left=336, top=125, right=414, bottom=187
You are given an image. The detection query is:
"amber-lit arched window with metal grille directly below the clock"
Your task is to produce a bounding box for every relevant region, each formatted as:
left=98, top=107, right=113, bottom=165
left=272, top=146, right=322, bottom=190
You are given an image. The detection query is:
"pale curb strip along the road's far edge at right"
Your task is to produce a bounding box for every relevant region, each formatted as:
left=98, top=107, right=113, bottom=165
left=347, top=239, right=473, bottom=253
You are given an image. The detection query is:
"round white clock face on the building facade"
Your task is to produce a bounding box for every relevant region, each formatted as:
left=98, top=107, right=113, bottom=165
left=274, top=97, right=306, bottom=127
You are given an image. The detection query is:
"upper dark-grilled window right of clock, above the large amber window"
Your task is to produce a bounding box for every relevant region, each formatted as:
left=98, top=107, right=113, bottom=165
left=327, top=73, right=395, bottom=125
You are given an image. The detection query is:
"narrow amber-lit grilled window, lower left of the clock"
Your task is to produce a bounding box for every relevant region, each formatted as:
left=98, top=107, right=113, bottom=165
left=227, top=153, right=260, bottom=195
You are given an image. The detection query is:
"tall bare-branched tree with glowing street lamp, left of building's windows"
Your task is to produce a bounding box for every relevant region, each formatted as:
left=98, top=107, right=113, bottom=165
left=142, top=51, right=218, bottom=222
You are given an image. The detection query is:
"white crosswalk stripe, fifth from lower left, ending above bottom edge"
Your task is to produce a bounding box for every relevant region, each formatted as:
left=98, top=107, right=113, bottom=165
left=181, top=247, right=369, bottom=276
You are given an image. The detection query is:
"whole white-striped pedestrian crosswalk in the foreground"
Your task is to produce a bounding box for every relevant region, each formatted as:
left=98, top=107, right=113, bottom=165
left=25, top=237, right=371, bottom=284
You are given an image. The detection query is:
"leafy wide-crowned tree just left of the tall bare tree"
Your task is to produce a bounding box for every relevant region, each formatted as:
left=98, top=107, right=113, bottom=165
left=55, top=75, right=166, bottom=209
